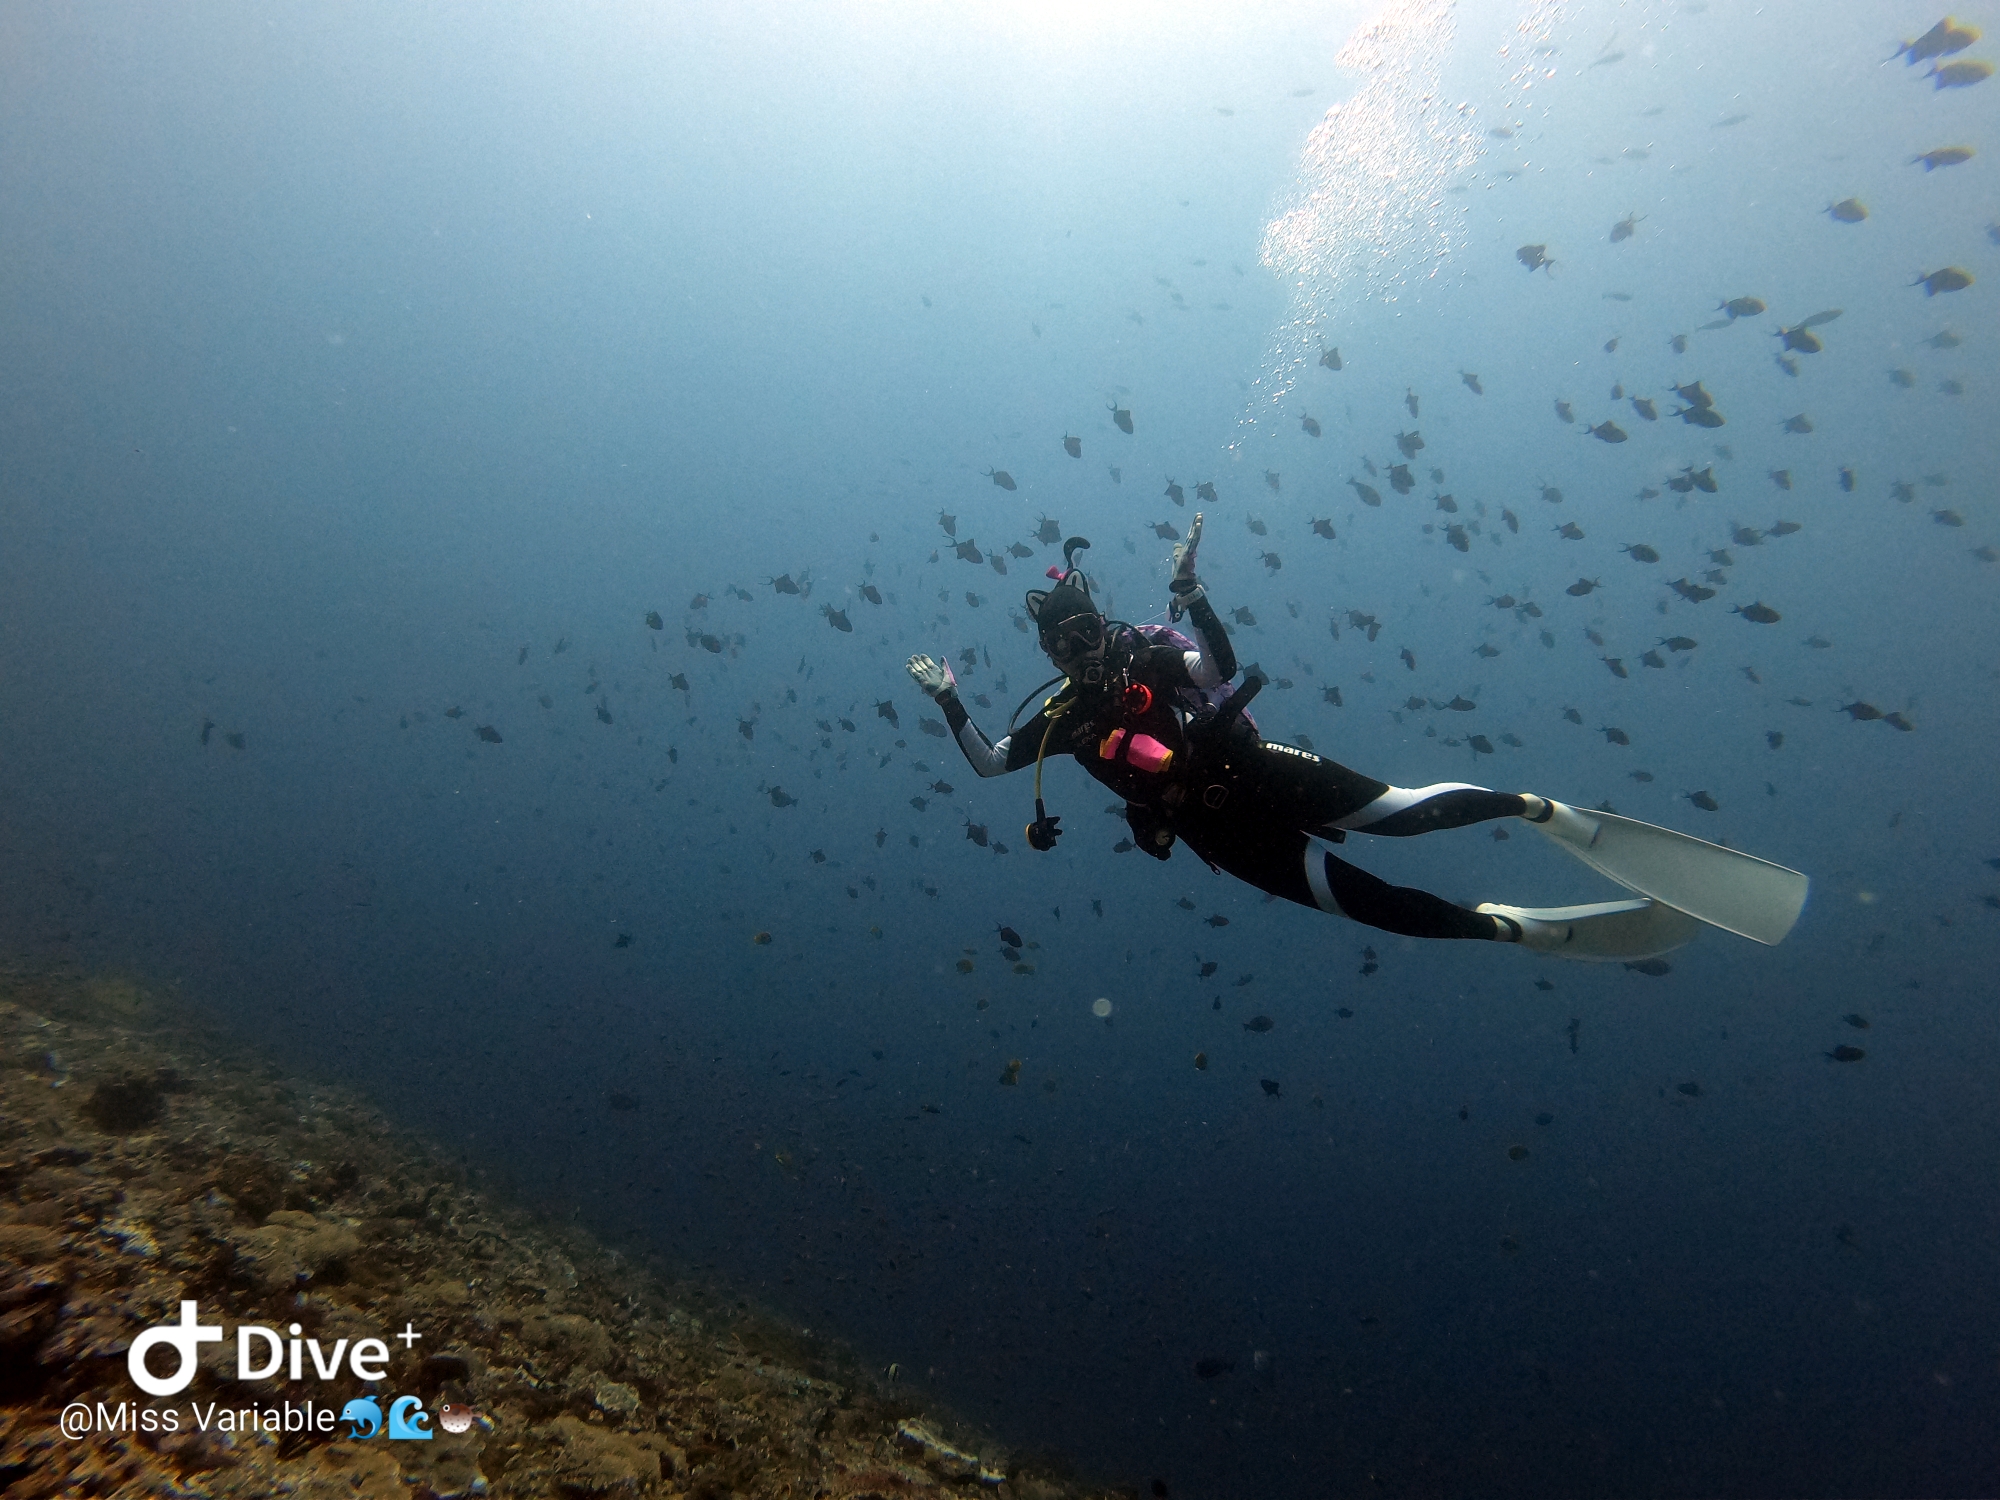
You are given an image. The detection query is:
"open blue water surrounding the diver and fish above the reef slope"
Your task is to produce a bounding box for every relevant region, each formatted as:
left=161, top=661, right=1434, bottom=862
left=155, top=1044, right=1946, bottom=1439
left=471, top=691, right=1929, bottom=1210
left=0, top=0, right=2000, bottom=1496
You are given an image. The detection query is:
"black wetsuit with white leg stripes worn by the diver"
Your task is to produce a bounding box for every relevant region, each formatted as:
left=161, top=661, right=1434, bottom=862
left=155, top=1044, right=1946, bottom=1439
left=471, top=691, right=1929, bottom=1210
left=938, top=598, right=1528, bottom=938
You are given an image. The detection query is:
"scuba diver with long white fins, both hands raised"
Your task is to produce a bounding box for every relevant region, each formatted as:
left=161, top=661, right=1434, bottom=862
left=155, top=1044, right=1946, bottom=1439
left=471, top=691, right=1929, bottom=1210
left=908, top=514, right=1806, bottom=960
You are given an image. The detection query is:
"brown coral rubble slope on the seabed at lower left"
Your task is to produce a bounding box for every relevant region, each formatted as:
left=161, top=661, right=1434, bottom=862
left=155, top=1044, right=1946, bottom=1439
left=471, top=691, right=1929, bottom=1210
left=0, top=974, right=1112, bottom=1500
